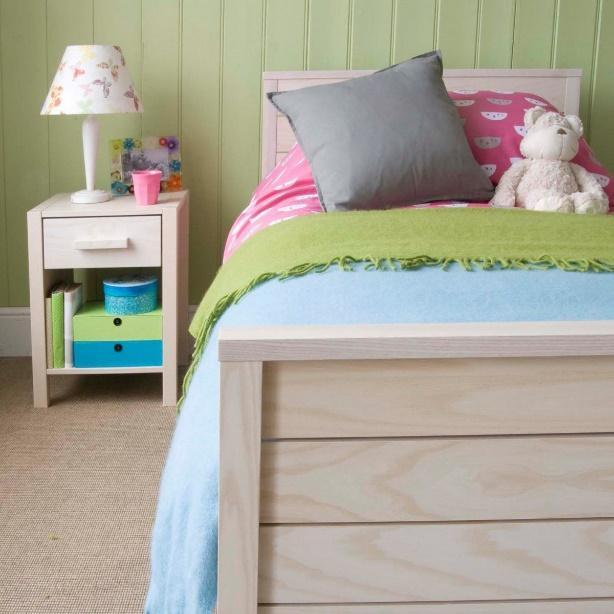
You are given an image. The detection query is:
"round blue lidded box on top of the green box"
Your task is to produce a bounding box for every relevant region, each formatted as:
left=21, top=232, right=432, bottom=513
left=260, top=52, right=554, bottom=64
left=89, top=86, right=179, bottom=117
left=102, top=275, right=158, bottom=316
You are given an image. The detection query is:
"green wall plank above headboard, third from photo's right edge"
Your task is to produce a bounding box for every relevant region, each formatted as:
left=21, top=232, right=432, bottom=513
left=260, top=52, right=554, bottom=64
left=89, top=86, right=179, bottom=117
left=512, top=0, right=556, bottom=68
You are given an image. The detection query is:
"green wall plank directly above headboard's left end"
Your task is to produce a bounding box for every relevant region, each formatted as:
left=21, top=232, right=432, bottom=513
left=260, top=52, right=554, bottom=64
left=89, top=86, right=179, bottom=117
left=264, top=0, right=306, bottom=70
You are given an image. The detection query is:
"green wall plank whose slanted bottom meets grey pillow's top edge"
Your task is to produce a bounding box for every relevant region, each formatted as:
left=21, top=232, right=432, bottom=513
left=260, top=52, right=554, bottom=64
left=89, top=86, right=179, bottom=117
left=392, top=0, right=437, bottom=62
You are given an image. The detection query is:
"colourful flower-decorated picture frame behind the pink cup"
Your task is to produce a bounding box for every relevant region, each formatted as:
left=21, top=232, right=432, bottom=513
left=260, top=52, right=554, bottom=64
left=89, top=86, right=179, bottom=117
left=110, top=136, right=183, bottom=196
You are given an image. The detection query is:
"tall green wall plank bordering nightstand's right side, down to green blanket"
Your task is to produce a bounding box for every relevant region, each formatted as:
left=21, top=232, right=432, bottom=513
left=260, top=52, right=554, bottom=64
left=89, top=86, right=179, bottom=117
left=181, top=0, right=222, bottom=303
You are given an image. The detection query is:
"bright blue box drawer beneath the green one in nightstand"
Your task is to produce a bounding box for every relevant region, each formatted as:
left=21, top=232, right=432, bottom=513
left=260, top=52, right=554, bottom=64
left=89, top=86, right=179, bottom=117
left=73, top=339, right=162, bottom=369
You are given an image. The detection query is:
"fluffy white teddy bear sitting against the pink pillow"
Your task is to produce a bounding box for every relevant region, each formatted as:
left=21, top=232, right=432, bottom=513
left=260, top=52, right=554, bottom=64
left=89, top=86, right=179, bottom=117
left=490, top=107, right=608, bottom=213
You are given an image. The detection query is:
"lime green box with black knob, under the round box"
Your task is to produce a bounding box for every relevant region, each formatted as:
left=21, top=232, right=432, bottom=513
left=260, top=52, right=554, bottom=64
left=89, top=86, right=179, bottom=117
left=73, top=302, right=162, bottom=341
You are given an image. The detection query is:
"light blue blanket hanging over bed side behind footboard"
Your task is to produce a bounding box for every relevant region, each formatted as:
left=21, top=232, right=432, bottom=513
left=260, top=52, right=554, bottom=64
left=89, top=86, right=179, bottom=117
left=145, top=266, right=614, bottom=614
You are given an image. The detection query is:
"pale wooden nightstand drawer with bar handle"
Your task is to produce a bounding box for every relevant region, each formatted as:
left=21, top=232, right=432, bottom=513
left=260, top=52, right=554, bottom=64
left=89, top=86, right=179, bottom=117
left=43, top=215, right=162, bottom=269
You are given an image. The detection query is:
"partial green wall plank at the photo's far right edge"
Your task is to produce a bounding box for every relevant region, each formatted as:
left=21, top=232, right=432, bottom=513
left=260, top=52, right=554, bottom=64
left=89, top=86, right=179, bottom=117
left=590, top=0, right=614, bottom=171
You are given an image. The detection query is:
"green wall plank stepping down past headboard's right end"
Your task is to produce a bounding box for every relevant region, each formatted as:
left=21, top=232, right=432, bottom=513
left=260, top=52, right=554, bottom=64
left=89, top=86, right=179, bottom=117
left=554, top=0, right=597, bottom=124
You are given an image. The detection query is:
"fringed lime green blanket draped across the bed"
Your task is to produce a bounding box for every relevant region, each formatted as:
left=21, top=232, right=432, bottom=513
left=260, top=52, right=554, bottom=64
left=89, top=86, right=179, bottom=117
left=186, top=208, right=614, bottom=398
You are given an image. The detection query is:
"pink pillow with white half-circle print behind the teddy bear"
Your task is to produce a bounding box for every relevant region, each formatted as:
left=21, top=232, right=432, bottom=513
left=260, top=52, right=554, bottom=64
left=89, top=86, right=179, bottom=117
left=448, top=90, right=614, bottom=206
